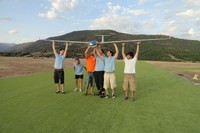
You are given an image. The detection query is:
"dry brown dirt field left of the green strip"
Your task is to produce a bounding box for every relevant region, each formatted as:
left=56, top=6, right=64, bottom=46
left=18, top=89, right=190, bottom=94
left=0, top=57, right=77, bottom=78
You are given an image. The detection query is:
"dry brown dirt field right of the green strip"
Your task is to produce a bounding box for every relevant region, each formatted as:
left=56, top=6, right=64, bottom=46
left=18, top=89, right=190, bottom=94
left=146, top=61, right=200, bottom=83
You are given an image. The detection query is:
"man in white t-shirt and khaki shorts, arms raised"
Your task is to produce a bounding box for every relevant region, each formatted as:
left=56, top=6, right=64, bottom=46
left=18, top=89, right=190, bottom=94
left=122, top=42, right=140, bottom=101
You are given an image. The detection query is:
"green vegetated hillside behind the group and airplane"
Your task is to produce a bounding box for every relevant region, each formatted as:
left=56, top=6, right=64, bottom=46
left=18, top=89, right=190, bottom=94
left=3, top=30, right=200, bottom=62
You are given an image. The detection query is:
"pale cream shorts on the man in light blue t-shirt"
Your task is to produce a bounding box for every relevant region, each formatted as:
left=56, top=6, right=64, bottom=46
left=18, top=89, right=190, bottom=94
left=103, top=72, right=117, bottom=89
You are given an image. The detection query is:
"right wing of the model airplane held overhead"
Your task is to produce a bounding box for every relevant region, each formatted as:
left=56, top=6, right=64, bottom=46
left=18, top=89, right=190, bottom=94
left=100, top=37, right=171, bottom=44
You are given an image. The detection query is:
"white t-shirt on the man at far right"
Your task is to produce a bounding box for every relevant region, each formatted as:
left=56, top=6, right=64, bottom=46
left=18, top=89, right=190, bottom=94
left=124, top=57, right=137, bottom=74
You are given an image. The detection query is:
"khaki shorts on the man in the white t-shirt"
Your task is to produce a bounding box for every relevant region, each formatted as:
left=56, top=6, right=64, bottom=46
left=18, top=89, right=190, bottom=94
left=124, top=74, right=136, bottom=91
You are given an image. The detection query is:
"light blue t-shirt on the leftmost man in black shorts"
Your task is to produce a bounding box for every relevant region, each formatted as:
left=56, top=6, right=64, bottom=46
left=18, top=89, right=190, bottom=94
left=54, top=54, right=65, bottom=69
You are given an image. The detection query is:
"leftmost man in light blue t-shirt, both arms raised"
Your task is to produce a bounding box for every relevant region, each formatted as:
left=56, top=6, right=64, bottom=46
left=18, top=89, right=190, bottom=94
left=52, top=41, right=68, bottom=94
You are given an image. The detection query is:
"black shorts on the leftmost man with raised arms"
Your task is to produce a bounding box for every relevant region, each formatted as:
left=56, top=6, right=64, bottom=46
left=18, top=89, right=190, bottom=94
left=54, top=69, right=64, bottom=84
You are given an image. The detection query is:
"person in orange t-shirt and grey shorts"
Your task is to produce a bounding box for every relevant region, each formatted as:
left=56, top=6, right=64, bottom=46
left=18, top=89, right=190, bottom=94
left=85, top=46, right=96, bottom=96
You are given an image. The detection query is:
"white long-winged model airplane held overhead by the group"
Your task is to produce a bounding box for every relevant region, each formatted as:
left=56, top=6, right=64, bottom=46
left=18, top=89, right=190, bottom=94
left=43, top=35, right=171, bottom=46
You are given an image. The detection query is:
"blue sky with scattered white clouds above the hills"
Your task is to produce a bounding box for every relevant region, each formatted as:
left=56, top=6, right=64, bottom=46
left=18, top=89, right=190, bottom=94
left=0, top=0, right=200, bottom=43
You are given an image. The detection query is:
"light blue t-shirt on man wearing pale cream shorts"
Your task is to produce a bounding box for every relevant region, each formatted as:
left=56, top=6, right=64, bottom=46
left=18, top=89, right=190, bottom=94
left=104, top=56, right=116, bottom=72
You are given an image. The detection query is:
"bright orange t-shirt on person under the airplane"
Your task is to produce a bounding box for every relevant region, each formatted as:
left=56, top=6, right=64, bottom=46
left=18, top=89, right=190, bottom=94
left=86, top=56, right=96, bottom=72
